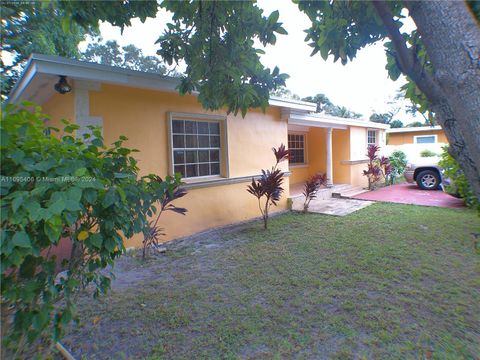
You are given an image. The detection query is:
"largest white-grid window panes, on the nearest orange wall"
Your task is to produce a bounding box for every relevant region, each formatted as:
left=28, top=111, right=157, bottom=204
left=171, top=118, right=220, bottom=178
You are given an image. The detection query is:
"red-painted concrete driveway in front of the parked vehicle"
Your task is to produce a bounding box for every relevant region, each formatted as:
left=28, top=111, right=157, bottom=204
left=353, top=183, right=464, bottom=208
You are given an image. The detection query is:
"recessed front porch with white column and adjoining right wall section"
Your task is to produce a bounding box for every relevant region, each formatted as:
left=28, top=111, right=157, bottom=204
left=282, top=109, right=388, bottom=198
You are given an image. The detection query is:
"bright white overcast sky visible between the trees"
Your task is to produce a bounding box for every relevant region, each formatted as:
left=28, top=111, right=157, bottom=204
left=88, top=0, right=418, bottom=124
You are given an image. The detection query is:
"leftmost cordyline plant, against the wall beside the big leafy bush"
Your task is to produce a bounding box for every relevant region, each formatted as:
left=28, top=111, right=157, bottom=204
left=142, top=173, right=187, bottom=260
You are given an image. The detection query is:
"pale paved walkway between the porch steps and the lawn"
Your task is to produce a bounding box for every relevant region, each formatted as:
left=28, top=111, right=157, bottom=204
left=292, top=196, right=373, bottom=216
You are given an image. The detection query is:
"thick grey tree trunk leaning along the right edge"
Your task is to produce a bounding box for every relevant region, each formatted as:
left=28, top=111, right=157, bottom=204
left=405, top=1, right=480, bottom=200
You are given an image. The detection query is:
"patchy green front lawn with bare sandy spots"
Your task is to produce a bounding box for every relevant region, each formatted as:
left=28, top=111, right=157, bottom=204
left=64, top=204, right=480, bottom=359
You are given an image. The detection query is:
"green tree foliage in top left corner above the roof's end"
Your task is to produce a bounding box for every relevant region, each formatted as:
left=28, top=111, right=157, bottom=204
left=0, top=1, right=89, bottom=96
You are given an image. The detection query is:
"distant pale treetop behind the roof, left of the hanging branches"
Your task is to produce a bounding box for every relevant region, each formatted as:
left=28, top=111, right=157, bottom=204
left=81, top=39, right=178, bottom=75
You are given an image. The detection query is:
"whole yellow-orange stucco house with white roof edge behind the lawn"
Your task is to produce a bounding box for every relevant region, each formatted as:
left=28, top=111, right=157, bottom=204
left=9, top=55, right=388, bottom=246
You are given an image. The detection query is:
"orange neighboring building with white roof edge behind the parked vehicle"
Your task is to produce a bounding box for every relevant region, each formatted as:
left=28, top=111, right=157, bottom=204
left=386, top=126, right=448, bottom=162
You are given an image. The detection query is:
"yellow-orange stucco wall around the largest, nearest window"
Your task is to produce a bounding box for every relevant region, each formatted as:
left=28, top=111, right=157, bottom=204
left=44, top=84, right=289, bottom=247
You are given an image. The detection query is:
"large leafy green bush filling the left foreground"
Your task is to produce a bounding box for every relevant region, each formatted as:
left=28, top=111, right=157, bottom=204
left=0, top=103, right=184, bottom=355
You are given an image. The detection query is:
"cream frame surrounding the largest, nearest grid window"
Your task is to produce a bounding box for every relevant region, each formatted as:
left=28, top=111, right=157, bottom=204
left=167, top=112, right=230, bottom=182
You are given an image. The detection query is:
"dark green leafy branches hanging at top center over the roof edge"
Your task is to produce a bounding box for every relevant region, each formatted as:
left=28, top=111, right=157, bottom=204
left=157, top=1, right=288, bottom=116
